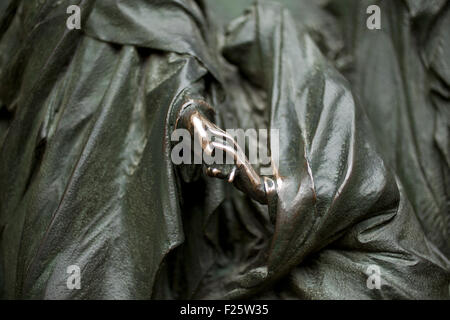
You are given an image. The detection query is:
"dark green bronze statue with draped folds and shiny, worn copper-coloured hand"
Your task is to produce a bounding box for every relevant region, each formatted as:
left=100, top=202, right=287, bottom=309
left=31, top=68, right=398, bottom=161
left=0, top=0, right=450, bottom=299
